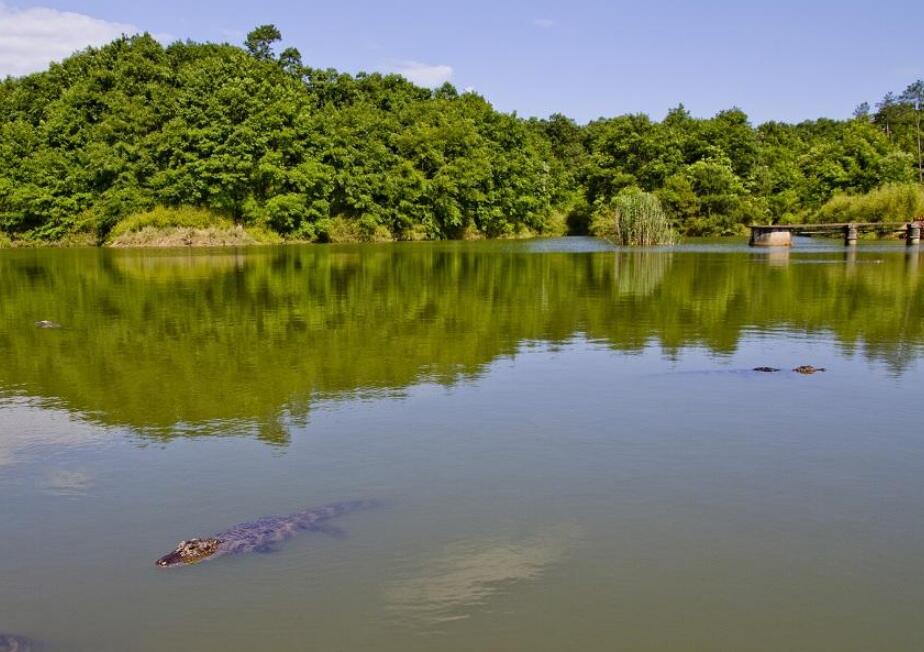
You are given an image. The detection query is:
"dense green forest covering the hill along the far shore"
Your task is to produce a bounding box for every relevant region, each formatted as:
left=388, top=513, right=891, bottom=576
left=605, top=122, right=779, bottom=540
left=0, top=25, right=924, bottom=244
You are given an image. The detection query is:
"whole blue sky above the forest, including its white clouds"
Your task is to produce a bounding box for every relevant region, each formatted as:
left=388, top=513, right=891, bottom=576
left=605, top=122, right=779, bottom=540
left=0, top=0, right=924, bottom=123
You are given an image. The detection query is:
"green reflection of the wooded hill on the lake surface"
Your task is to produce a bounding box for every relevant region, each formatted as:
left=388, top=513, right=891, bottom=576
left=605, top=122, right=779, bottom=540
left=0, top=244, right=924, bottom=443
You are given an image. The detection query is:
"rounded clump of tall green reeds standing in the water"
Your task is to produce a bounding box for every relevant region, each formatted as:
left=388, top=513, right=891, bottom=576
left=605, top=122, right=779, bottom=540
left=590, top=190, right=676, bottom=246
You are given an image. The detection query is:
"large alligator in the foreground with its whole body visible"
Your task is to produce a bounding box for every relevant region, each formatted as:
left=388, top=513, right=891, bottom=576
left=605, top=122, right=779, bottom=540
left=157, top=500, right=379, bottom=568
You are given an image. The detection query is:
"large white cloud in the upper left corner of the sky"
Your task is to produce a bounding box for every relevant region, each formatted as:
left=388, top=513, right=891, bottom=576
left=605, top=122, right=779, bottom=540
left=0, top=2, right=138, bottom=77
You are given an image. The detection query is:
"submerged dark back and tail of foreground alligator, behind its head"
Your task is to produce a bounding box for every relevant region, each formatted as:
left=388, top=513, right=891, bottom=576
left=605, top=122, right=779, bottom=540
left=215, top=500, right=379, bottom=554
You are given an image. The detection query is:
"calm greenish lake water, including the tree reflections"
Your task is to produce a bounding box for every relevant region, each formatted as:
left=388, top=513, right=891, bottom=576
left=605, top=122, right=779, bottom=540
left=0, top=238, right=924, bottom=652
